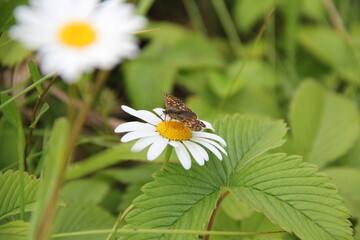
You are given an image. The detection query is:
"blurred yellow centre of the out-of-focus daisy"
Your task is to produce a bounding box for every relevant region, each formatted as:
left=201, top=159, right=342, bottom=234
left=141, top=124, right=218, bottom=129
left=59, top=22, right=96, bottom=47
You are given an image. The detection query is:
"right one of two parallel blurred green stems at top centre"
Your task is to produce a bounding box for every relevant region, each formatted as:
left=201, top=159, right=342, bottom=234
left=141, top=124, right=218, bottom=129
left=212, top=0, right=243, bottom=55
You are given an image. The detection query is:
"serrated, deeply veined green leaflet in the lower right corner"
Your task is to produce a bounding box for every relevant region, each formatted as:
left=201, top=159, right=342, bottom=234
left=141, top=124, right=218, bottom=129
left=229, top=154, right=353, bottom=240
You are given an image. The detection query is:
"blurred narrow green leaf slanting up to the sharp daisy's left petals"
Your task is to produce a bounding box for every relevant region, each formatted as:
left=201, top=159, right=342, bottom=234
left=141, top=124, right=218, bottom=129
left=65, top=143, right=146, bottom=180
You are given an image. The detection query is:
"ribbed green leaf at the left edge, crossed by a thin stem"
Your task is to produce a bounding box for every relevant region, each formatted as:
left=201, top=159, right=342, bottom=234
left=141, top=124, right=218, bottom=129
left=0, top=170, right=39, bottom=219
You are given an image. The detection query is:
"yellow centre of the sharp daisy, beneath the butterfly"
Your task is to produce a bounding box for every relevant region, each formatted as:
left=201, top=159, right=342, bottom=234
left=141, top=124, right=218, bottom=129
left=156, top=121, right=191, bottom=141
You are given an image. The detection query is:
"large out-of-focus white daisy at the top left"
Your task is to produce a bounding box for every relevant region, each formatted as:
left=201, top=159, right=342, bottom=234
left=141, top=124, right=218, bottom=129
left=10, top=0, right=146, bottom=83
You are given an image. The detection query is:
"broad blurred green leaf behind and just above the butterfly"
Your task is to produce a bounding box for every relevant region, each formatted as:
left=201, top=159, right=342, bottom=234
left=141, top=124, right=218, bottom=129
left=123, top=21, right=223, bottom=109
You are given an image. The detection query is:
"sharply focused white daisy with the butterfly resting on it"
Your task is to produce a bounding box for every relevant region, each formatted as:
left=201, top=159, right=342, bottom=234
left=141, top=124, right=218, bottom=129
left=115, top=105, right=227, bottom=169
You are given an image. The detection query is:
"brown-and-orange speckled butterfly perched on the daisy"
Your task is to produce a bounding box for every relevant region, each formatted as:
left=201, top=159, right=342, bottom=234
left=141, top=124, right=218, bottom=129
left=164, top=93, right=205, bottom=131
